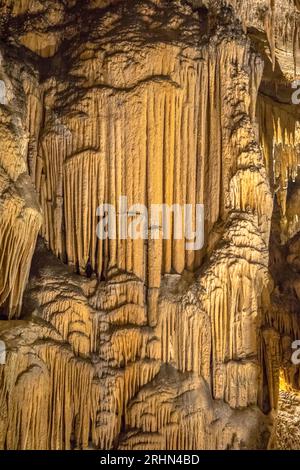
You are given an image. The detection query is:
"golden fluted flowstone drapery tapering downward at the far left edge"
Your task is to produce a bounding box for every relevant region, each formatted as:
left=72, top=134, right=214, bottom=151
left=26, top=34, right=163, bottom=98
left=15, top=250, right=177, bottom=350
left=0, top=47, right=42, bottom=318
